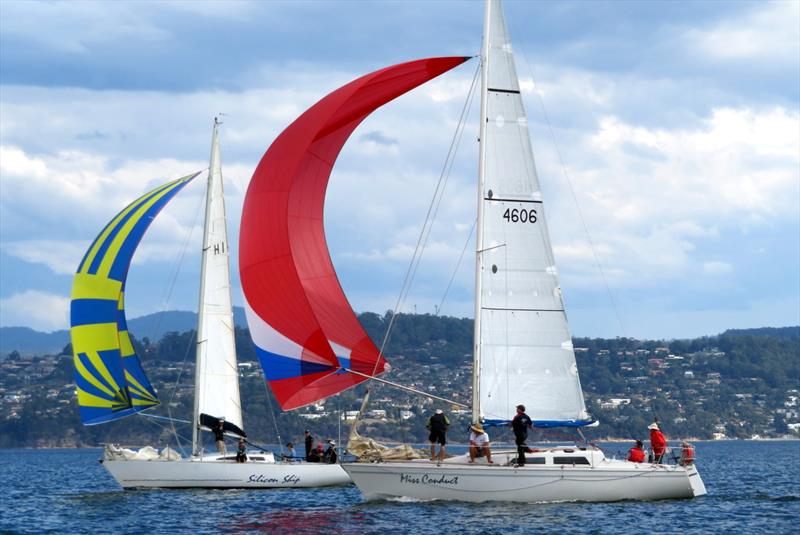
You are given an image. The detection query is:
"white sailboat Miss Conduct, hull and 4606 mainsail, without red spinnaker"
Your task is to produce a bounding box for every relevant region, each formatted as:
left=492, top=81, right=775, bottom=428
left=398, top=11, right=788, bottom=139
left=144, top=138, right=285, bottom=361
left=343, top=0, right=706, bottom=502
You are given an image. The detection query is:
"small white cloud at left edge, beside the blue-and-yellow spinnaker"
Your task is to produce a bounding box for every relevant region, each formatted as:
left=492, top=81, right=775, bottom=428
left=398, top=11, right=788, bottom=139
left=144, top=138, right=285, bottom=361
left=0, top=290, right=69, bottom=331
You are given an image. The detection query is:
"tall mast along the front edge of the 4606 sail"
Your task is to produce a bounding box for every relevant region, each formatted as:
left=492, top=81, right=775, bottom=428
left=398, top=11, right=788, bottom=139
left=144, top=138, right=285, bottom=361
left=472, top=0, right=492, bottom=422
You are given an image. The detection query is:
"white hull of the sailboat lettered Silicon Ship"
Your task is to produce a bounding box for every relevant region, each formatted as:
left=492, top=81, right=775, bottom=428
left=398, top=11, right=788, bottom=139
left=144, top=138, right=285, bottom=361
left=101, top=456, right=350, bottom=489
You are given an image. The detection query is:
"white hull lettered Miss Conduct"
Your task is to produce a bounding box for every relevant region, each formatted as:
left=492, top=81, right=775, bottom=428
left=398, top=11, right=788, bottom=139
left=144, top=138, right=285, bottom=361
left=343, top=452, right=706, bottom=503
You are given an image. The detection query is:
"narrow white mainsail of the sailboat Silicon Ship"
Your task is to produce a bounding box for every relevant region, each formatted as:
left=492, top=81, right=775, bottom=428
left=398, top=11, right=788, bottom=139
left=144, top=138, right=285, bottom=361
left=195, top=124, right=242, bottom=429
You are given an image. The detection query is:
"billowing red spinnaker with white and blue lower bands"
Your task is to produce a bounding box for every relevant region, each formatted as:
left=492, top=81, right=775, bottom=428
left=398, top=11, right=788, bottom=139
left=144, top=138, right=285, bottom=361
left=239, top=57, right=469, bottom=410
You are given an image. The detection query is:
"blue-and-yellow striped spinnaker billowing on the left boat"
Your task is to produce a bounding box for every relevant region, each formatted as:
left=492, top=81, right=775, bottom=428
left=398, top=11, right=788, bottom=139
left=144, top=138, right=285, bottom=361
left=70, top=173, right=197, bottom=425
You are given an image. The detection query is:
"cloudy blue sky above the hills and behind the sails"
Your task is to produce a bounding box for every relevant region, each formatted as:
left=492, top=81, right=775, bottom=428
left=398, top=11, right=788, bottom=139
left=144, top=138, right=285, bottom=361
left=0, top=0, right=800, bottom=339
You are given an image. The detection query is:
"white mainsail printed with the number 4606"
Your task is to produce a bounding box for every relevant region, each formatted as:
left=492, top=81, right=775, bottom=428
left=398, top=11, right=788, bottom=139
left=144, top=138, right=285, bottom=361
left=476, top=0, right=589, bottom=427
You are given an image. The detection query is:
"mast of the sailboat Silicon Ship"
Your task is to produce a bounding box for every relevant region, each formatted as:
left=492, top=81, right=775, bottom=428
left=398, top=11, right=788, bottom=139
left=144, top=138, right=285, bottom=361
left=192, top=117, right=220, bottom=455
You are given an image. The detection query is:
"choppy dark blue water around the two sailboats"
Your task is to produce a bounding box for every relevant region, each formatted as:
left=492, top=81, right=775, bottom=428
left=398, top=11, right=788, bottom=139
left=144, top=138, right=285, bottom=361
left=0, top=441, right=800, bottom=535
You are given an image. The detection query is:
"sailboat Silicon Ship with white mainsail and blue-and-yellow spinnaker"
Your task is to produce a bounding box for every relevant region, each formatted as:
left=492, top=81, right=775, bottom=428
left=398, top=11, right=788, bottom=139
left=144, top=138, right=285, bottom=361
left=72, top=120, right=350, bottom=488
